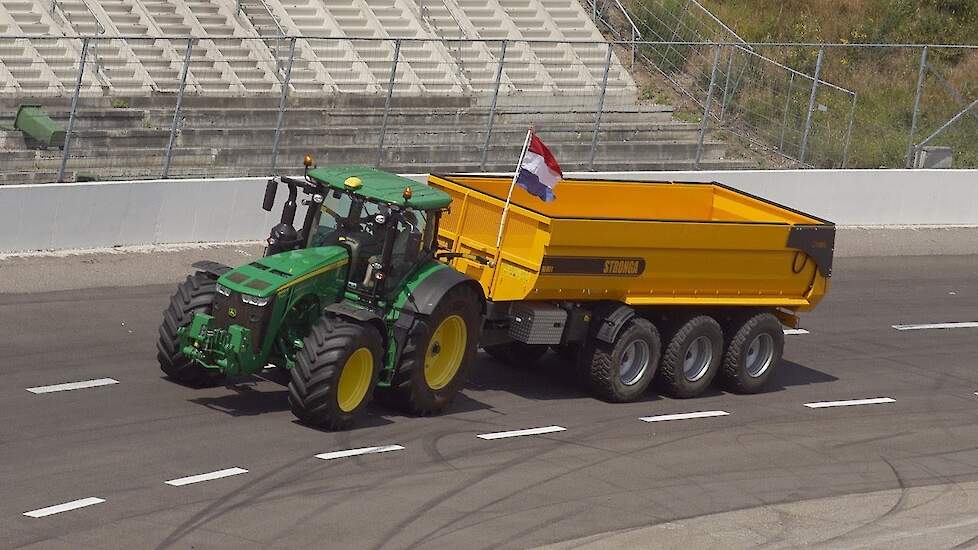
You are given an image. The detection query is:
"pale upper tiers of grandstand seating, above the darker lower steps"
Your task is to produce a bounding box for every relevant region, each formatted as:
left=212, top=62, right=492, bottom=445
left=0, top=0, right=635, bottom=96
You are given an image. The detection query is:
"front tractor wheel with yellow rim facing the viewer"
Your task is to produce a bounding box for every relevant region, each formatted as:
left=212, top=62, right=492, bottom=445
left=289, top=316, right=383, bottom=430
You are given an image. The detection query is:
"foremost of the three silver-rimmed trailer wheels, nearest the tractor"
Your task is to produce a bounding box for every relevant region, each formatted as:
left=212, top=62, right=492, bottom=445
left=583, top=317, right=662, bottom=403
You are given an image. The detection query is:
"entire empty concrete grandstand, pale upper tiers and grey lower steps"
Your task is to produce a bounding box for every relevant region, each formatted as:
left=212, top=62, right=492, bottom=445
left=0, top=0, right=747, bottom=184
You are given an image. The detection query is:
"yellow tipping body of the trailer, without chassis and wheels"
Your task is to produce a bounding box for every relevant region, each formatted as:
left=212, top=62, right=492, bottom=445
left=428, top=175, right=835, bottom=312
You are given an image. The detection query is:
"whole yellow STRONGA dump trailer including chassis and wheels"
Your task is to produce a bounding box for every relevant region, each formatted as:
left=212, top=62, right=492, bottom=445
left=428, top=175, right=835, bottom=400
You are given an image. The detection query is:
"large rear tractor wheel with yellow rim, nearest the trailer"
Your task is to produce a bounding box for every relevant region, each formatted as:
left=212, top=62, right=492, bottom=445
left=388, top=286, right=481, bottom=416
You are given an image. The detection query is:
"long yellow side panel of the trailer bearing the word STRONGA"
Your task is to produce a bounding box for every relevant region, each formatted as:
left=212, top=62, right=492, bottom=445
left=532, top=220, right=824, bottom=309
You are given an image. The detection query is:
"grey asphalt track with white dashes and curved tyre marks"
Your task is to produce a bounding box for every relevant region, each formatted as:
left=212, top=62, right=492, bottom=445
left=0, top=256, right=978, bottom=549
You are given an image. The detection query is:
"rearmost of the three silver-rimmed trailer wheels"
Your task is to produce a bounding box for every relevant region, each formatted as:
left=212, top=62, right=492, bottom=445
left=718, top=313, right=784, bottom=393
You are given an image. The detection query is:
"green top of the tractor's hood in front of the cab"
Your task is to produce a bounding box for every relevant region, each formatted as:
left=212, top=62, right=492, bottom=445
left=217, top=246, right=350, bottom=298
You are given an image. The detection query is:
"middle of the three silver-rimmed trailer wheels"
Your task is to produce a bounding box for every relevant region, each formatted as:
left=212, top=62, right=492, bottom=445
left=656, top=315, right=723, bottom=398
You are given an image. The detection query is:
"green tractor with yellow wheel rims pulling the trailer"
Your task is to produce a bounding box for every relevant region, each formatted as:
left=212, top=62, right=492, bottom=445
left=157, top=162, right=486, bottom=430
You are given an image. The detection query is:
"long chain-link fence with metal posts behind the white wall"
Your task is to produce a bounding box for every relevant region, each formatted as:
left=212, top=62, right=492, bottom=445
left=0, top=34, right=978, bottom=183
